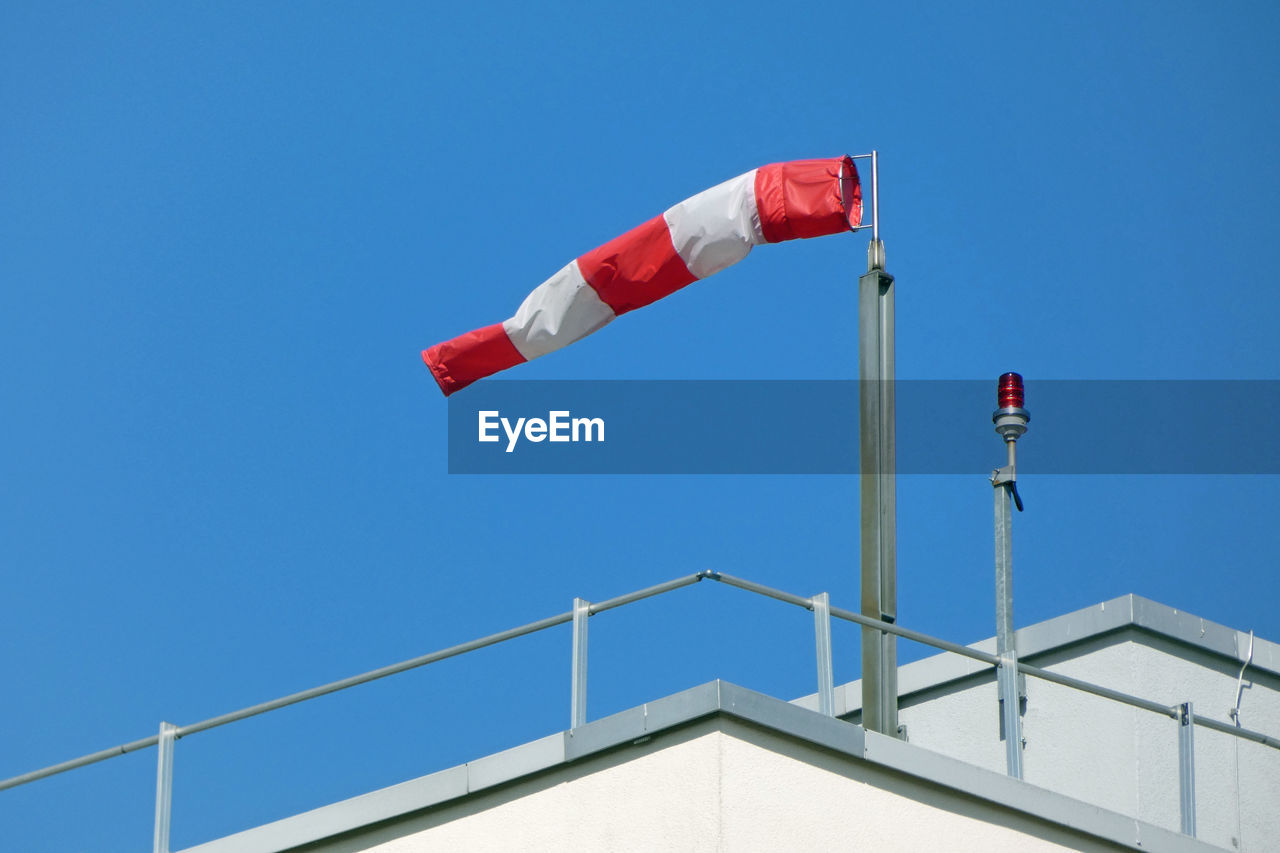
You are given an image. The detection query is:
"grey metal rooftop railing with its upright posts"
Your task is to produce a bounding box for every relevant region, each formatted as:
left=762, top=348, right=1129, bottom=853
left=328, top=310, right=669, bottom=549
left=0, top=571, right=1280, bottom=853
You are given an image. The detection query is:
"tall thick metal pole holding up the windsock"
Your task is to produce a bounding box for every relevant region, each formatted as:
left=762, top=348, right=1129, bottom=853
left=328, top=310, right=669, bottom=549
left=858, top=151, right=897, bottom=736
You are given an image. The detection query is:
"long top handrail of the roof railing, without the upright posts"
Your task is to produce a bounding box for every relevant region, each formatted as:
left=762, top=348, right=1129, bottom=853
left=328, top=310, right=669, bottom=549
left=0, top=571, right=1280, bottom=790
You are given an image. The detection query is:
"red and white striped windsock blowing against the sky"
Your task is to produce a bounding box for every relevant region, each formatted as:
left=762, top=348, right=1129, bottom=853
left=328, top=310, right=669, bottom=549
left=422, top=156, right=863, bottom=396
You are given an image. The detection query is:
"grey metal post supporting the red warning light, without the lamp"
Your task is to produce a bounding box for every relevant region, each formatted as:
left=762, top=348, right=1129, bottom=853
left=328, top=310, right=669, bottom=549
left=992, top=442, right=1023, bottom=779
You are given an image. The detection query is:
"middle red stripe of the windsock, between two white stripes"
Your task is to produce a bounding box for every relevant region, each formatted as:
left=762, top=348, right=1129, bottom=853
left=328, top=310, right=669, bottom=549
left=577, top=216, right=698, bottom=314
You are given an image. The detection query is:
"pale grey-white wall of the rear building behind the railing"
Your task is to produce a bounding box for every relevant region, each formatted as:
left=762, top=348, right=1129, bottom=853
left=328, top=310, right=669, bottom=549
left=890, top=629, right=1280, bottom=852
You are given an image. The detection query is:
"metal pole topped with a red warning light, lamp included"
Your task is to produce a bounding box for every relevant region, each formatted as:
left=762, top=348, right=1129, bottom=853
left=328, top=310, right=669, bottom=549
left=991, top=373, right=1032, bottom=779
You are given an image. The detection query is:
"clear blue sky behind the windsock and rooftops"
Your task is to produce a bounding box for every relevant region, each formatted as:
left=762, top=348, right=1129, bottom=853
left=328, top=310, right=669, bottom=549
left=0, top=3, right=1280, bottom=850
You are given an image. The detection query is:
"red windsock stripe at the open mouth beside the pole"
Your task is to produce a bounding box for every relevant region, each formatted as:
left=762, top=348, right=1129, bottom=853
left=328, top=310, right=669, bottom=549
left=755, top=156, right=863, bottom=243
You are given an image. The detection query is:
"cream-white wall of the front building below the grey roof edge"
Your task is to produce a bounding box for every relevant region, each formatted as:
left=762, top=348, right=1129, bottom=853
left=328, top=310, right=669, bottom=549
left=345, top=721, right=1119, bottom=853
